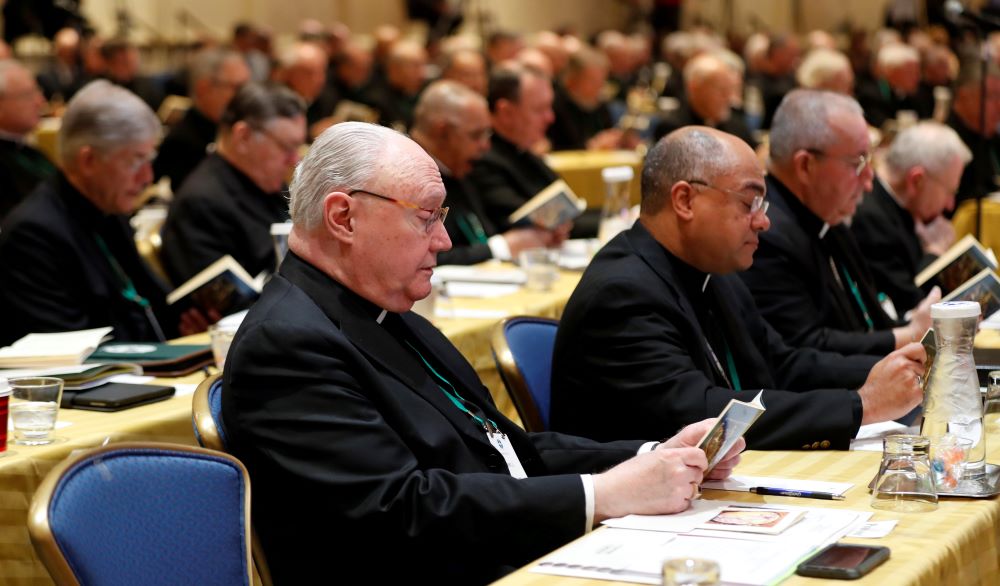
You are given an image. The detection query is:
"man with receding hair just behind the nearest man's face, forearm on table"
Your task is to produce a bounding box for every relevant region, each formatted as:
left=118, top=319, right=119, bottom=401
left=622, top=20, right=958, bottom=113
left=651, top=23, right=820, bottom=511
left=411, top=80, right=569, bottom=264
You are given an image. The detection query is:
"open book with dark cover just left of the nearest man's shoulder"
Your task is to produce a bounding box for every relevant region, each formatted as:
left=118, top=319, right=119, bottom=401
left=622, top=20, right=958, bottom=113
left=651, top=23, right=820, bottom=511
left=167, top=254, right=264, bottom=315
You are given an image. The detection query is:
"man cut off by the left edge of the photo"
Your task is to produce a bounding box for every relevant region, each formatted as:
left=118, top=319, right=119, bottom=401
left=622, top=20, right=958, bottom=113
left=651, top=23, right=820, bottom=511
left=0, top=59, right=56, bottom=220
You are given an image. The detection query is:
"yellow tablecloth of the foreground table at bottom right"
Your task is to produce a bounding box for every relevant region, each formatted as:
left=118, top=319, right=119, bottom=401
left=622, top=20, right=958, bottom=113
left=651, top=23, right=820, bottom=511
left=495, top=442, right=1000, bottom=586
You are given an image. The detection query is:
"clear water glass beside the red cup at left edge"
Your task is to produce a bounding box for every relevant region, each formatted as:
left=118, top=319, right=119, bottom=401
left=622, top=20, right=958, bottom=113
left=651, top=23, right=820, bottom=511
left=8, top=376, right=63, bottom=446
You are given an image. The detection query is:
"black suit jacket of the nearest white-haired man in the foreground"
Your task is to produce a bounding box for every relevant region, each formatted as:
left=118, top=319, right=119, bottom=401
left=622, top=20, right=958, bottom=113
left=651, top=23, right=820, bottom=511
left=222, top=252, right=641, bottom=584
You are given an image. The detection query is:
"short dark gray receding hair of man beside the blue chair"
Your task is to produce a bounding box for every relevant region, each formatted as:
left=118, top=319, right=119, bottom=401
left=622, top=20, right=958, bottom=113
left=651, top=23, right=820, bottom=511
left=640, top=126, right=731, bottom=214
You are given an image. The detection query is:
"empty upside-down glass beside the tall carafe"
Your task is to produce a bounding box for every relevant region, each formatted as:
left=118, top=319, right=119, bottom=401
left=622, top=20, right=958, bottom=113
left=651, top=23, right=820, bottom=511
left=871, top=435, right=937, bottom=513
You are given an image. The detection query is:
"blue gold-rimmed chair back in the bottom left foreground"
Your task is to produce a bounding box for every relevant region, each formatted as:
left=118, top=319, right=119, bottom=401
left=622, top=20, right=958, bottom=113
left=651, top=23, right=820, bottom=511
left=28, top=443, right=252, bottom=586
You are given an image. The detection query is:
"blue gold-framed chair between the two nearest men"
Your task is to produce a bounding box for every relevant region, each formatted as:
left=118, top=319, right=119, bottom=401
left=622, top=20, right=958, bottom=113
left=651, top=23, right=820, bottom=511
left=491, top=316, right=559, bottom=431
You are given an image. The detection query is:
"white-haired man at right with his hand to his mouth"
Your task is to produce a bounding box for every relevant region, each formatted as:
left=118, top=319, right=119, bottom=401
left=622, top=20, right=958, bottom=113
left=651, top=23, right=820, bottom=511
left=851, top=122, right=972, bottom=313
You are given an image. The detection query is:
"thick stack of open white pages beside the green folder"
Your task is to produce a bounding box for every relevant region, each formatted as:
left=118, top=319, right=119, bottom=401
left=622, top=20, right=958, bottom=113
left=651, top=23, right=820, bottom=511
left=0, top=327, right=111, bottom=368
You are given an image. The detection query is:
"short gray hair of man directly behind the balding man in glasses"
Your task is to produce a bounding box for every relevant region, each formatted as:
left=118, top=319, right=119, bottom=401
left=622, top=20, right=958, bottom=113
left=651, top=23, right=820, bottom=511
left=770, top=89, right=864, bottom=164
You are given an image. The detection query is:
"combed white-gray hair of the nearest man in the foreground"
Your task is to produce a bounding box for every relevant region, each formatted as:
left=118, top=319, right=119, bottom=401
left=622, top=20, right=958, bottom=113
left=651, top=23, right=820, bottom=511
left=288, top=122, right=402, bottom=231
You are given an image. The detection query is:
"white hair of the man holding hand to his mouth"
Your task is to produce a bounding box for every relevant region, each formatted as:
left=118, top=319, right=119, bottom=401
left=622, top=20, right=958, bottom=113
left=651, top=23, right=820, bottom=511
left=885, top=122, right=972, bottom=175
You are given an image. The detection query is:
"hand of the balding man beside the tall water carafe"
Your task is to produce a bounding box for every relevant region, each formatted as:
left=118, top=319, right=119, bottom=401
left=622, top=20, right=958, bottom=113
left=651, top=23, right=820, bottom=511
left=858, top=342, right=927, bottom=425
